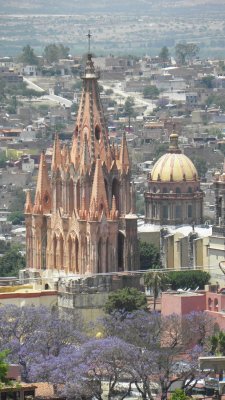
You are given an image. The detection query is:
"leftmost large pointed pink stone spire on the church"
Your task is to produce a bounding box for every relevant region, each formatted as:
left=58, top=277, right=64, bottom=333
left=34, top=151, right=51, bottom=213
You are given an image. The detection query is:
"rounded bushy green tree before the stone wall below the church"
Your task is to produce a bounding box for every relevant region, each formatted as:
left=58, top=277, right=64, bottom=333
left=105, top=287, right=147, bottom=314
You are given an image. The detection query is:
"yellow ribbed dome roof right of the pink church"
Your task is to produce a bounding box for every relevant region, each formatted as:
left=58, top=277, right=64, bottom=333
left=151, top=153, right=198, bottom=182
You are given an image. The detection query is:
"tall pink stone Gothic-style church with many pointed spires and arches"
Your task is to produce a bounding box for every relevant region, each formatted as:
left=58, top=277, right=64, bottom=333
left=25, top=54, right=139, bottom=274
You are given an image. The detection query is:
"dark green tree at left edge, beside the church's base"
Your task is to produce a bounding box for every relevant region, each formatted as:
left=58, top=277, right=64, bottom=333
left=0, top=246, right=25, bottom=276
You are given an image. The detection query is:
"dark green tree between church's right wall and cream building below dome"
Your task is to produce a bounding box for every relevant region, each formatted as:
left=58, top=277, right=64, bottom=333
left=139, top=242, right=160, bottom=269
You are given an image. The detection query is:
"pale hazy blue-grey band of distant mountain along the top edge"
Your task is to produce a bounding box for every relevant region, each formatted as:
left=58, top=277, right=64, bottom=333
left=0, top=0, right=224, bottom=15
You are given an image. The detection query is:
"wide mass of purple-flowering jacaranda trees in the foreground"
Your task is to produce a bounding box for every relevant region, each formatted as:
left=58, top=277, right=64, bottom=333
left=0, top=305, right=214, bottom=400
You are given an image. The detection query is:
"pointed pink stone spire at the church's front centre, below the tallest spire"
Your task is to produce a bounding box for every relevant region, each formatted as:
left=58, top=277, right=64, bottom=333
left=90, top=158, right=109, bottom=219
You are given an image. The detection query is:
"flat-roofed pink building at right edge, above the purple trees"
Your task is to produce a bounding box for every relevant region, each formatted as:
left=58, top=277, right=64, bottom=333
left=161, top=291, right=225, bottom=329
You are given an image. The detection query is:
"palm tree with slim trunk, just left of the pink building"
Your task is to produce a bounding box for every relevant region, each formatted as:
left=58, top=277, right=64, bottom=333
left=144, top=271, right=169, bottom=310
